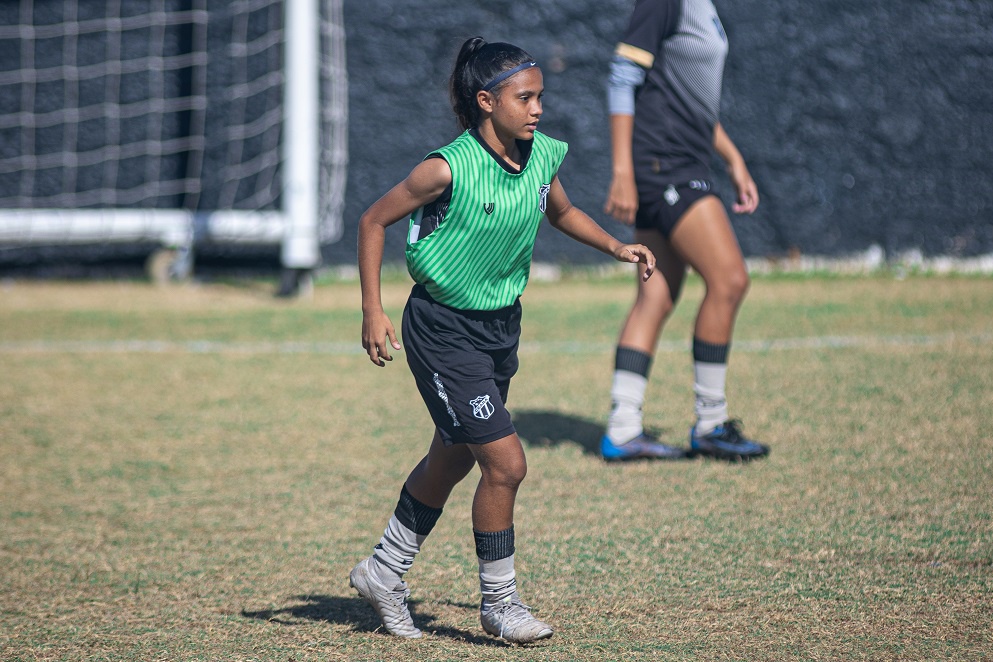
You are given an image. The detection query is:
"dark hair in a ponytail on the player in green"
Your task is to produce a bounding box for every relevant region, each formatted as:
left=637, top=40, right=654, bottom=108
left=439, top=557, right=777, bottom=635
left=448, top=37, right=533, bottom=129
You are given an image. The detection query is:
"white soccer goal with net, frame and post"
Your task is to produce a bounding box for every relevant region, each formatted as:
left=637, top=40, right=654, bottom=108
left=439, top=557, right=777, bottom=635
left=0, top=0, right=347, bottom=269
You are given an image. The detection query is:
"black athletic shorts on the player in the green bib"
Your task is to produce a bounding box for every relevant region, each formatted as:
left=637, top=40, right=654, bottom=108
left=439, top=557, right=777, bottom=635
left=402, top=285, right=521, bottom=446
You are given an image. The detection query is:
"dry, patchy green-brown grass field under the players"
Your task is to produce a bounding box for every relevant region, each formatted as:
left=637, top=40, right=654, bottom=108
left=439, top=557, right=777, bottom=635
left=0, top=274, right=993, bottom=661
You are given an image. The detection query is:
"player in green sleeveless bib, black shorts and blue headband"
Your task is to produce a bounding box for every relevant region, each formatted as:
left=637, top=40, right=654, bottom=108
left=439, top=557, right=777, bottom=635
left=350, top=37, right=655, bottom=643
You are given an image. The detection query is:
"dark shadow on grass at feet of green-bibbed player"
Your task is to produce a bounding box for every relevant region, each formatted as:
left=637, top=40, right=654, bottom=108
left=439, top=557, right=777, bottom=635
left=241, top=595, right=510, bottom=648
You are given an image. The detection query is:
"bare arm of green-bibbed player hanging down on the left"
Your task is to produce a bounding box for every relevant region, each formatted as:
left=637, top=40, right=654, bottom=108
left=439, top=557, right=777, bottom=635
left=358, top=159, right=452, bottom=366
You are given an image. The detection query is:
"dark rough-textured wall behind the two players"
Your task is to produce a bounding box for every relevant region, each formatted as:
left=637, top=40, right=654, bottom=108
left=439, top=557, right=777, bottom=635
left=326, top=0, right=993, bottom=264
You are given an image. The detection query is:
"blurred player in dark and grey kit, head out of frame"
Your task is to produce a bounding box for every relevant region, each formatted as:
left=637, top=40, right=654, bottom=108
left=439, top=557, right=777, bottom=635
left=600, top=0, right=769, bottom=460
